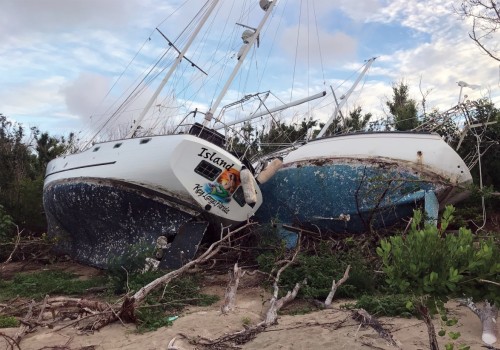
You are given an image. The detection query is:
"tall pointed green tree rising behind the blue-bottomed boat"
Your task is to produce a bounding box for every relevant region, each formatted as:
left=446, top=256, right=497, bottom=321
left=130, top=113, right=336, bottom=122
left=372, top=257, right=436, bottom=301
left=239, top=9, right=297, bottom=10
left=386, top=81, right=419, bottom=131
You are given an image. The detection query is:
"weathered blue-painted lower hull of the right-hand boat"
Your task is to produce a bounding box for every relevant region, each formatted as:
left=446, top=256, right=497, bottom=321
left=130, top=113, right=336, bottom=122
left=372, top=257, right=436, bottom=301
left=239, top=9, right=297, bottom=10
left=256, top=162, right=435, bottom=233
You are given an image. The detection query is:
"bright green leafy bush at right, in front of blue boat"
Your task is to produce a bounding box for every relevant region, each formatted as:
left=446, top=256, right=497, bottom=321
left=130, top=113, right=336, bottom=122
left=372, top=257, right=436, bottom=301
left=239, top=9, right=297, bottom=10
left=377, top=206, right=500, bottom=303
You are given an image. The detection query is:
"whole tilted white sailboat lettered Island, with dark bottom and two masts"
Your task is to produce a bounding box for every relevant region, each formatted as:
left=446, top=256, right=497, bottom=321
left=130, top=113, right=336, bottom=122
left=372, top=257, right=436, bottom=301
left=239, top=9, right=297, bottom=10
left=44, top=0, right=282, bottom=268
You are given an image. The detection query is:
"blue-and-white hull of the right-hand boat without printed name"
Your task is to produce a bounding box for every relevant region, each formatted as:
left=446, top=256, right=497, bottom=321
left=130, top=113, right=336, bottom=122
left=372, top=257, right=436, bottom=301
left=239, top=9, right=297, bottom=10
left=257, top=133, right=471, bottom=233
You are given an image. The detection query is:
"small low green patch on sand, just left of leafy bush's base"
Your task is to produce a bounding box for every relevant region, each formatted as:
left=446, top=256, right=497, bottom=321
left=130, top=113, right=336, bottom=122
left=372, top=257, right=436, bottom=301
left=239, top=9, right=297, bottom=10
left=343, top=294, right=417, bottom=317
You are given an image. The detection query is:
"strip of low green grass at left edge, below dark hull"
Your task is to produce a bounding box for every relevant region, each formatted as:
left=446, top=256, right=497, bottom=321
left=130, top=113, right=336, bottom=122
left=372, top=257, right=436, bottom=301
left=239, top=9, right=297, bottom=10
left=0, top=270, right=104, bottom=301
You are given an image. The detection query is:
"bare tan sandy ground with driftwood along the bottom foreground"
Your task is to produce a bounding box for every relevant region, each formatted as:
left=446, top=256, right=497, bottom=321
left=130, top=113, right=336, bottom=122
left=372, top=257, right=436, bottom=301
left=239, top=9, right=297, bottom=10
left=0, top=262, right=492, bottom=350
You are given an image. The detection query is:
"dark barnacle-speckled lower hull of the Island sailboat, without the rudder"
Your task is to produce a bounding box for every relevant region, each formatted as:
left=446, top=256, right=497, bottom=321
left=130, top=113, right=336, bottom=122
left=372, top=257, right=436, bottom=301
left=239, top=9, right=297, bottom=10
left=44, top=178, right=198, bottom=268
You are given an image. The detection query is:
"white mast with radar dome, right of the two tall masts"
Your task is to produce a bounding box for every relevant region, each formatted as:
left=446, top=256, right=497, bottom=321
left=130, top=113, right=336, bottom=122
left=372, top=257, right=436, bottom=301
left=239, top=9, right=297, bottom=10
left=203, top=0, right=277, bottom=126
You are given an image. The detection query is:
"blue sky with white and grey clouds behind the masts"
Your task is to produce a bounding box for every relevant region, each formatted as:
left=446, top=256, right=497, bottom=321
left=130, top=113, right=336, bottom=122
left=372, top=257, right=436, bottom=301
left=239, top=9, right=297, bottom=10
left=0, top=0, right=500, bottom=139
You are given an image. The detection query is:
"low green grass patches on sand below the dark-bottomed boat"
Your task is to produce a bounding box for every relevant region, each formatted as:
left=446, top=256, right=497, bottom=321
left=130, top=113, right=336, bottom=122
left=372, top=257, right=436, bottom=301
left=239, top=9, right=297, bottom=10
left=0, top=270, right=219, bottom=333
